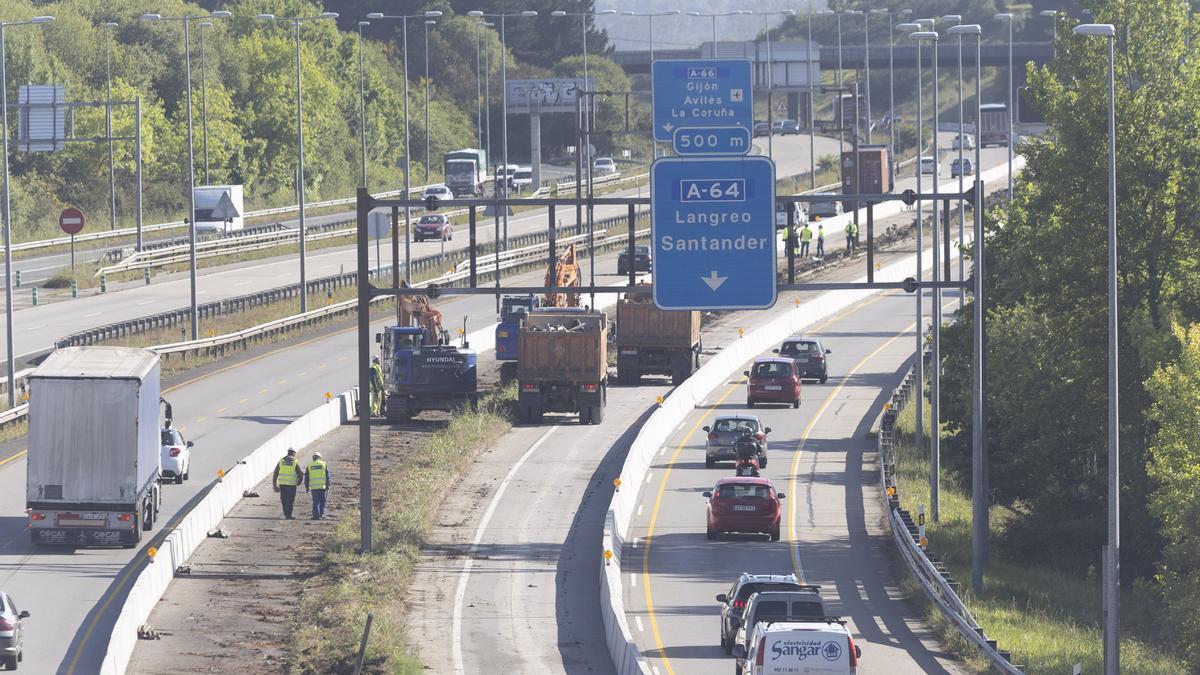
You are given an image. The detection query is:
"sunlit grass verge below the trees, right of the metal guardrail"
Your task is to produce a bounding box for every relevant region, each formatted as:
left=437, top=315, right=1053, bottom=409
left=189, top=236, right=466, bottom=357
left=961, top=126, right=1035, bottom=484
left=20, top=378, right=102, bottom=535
left=896, top=391, right=1187, bottom=675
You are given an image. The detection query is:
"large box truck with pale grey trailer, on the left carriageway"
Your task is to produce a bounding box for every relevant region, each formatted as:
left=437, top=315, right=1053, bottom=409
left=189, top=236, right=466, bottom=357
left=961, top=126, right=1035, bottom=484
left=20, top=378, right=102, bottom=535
left=25, top=347, right=162, bottom=548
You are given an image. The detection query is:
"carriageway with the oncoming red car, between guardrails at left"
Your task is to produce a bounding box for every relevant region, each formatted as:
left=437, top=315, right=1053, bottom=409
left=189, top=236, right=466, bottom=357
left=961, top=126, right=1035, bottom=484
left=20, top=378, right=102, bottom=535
left=0, top=136, right=836, bottom=363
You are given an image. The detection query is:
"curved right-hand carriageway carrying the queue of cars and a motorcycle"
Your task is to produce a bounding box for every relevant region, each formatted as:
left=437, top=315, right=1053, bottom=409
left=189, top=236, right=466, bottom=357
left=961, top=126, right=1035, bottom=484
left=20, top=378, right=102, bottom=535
left=622, top=293, right=959, bottom=674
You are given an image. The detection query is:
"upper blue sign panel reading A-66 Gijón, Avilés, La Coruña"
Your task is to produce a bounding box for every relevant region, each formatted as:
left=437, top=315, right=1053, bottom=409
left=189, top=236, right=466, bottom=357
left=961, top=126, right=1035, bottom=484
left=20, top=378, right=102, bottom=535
left=650, top=59, right=754, bottom=141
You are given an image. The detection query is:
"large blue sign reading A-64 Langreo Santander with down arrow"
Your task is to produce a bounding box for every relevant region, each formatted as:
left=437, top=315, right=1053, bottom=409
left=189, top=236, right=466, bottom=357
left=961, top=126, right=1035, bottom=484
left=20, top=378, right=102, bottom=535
left=650, top=156, right=776, bottom=310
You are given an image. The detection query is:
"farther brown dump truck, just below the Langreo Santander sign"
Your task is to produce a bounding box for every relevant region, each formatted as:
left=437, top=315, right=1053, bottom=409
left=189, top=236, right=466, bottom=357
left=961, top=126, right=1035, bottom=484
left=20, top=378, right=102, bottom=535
left=614, top=292, right=701, bottom=386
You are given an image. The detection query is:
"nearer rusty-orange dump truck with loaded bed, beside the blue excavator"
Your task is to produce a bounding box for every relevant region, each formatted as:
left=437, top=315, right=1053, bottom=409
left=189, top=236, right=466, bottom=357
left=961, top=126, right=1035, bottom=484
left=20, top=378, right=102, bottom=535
left=517, top=307, right=608, bottom=424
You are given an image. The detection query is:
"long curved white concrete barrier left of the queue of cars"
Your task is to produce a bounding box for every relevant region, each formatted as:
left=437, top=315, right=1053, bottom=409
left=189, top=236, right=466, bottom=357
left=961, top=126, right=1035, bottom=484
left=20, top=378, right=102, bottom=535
left=590, top=157, right=1025, bottom=675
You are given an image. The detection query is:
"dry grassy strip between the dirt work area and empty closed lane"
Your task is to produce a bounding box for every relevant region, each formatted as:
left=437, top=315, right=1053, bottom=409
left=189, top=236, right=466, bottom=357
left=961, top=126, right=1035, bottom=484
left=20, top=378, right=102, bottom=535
left=292, top=386, right=516, bottom=674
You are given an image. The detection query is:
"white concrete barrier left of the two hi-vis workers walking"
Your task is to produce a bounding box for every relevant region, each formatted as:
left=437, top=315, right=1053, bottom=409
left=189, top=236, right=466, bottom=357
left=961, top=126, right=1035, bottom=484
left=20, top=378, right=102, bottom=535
left=101, top=389, right=358, bottom=675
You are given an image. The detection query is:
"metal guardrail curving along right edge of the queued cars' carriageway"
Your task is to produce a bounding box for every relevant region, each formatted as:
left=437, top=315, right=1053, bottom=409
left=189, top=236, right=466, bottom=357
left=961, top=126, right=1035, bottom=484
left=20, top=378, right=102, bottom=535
left=876, top=352, right=1024, bottom=675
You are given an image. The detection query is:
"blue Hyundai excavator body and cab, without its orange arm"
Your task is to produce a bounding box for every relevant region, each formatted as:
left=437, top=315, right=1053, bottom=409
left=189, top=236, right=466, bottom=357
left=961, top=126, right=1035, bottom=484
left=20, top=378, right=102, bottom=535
left=376, top=325, right=479, bottom=424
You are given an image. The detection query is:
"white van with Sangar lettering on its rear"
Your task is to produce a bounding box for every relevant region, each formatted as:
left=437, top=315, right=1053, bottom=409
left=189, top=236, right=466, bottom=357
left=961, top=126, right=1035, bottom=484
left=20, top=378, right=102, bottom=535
left=733, top=617, right=863, bottom=675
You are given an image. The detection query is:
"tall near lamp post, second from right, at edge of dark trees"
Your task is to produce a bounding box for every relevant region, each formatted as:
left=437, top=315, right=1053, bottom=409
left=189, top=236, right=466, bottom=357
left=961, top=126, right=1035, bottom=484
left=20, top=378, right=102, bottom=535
left=946, top=24, right=988, bottom=593
